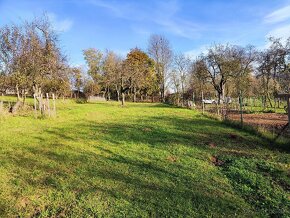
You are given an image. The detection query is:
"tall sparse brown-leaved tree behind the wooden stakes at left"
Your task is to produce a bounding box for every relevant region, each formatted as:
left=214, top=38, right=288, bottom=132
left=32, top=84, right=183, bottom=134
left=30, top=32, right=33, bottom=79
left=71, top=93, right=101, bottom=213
left=26, top=15, right=69, bottom=103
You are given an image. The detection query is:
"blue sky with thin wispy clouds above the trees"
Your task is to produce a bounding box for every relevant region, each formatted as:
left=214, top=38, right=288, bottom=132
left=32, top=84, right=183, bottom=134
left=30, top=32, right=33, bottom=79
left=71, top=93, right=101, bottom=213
left=0, top=0, right=290, bottom=65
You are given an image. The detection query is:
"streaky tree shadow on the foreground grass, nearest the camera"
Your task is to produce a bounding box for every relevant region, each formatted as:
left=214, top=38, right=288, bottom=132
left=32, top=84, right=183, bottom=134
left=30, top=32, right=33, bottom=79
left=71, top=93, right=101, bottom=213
left=6, top=136, right=255, bottom=216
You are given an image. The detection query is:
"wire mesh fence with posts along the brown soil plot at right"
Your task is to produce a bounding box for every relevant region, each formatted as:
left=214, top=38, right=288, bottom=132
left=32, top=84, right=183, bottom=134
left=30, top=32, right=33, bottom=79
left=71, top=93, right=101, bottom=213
left=195, top=97, right=290, bottom=134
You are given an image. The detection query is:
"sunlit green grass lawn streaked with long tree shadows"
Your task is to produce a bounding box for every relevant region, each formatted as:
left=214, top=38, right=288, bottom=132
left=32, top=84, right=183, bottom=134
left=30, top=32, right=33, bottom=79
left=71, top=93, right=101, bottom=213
left=0, top=101, right=290, bottom=217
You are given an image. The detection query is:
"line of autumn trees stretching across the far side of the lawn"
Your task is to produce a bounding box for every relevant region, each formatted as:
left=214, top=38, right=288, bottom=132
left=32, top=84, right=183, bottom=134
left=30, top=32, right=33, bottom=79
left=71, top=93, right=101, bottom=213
left=0, top=16, right=290, bottom=106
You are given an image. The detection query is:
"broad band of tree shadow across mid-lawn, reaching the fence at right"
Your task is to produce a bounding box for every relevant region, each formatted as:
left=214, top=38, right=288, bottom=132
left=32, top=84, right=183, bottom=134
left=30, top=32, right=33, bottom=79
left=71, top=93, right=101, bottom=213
left=30, top=112, right=289, bottom=160
